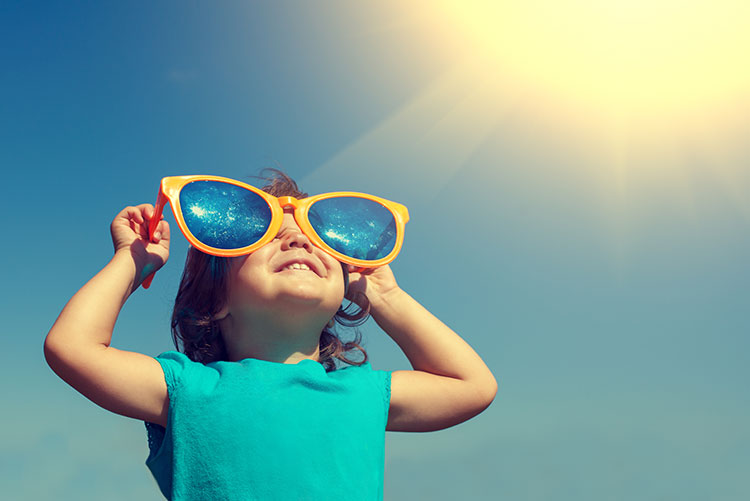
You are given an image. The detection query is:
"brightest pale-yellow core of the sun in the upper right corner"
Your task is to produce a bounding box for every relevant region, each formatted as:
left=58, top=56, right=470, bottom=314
left=435, top=0, right=750, bottom=122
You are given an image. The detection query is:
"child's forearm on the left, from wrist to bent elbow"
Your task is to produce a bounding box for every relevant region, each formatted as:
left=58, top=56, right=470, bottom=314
left=45, top=251, right=140, bottom=350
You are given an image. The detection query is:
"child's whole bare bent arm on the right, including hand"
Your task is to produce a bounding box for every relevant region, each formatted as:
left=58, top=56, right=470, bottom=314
left=352, top=266, right=497, bottom=431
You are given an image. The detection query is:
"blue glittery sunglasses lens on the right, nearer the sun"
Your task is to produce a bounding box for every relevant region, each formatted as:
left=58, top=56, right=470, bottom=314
left=307, top=197, right=396, bottom=261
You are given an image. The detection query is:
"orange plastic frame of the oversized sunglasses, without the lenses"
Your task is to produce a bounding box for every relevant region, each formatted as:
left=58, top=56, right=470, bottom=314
left=143, top=175, right=409, bottom=289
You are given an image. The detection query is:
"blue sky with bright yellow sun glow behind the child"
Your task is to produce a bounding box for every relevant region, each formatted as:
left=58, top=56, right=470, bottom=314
left=0, top=0, right=750, bottom=501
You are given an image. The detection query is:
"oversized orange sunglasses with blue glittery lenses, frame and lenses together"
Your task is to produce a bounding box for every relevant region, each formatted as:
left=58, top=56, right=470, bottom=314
left=143, top=176, right=409, bottom=288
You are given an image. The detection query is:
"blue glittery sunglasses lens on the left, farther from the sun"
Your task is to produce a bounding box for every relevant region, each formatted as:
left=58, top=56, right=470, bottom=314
left=180, top=181, right=271, bottom=250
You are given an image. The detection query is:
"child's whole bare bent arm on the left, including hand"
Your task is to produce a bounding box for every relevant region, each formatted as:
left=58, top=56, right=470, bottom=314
left=44, top=204, right=169, bottom=424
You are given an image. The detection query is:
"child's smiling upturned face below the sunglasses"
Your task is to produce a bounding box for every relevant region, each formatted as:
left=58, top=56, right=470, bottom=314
left=219, top=209, right=344, bottom=327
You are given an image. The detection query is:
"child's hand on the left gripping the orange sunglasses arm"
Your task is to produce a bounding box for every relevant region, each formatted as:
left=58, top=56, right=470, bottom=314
left=109, top=204, right=169, bottom=283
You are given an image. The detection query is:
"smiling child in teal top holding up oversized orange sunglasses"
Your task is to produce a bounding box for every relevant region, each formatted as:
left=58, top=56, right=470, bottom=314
left=44, top=170, right=497, bottom=500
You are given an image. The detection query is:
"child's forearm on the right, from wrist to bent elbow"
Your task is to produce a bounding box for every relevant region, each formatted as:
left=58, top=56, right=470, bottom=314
left=371, top=288, right=497, bottom=386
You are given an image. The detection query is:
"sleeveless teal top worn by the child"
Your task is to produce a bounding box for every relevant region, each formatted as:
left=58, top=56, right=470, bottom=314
left=144, top=351, right=391, bottom=501
